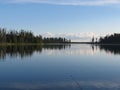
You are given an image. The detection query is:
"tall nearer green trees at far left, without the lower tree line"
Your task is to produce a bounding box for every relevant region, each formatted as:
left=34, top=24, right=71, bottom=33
left=0, top=28, right=42, bottom=44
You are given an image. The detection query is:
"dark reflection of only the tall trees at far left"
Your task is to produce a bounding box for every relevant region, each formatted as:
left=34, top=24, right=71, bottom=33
left=0, top=45, right=42, bottom=59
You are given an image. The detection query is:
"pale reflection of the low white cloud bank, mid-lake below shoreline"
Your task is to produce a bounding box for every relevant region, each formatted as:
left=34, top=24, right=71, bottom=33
left=44, top=44, right=99, bottom=56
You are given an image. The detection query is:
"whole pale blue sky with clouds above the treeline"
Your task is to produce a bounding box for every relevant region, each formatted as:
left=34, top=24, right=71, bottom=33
left=0, top=0, right=120, bottom=39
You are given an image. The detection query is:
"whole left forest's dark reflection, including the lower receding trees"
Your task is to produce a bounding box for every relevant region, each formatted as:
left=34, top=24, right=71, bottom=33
left=0, top=44, right=70, bottom=60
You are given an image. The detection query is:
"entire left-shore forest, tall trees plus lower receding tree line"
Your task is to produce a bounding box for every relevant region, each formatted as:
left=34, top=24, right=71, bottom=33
left=0, top=28, right=71, bottom=44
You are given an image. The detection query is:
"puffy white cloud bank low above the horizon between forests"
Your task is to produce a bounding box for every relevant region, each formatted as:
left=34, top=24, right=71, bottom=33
left=43, top=32, right=98, bottom=42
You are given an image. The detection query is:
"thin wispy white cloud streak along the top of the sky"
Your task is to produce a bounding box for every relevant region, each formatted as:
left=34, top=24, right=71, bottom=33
left=0, top=0, right=120, bottom=6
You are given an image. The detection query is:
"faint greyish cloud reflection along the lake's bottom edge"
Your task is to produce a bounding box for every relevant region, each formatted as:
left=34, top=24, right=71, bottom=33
left=0, top=81, right=120, bottom=90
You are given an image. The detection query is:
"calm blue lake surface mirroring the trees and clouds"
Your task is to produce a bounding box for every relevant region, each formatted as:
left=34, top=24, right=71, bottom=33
left=0, top=44, right=120, bottom=90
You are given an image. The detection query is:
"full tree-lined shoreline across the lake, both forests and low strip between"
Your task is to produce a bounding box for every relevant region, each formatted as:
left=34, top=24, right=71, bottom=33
left=0, top=28, right=120, bottom=46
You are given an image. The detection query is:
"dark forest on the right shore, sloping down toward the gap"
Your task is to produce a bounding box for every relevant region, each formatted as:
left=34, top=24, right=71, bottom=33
left=98, top=33, right=120, bottom=44
